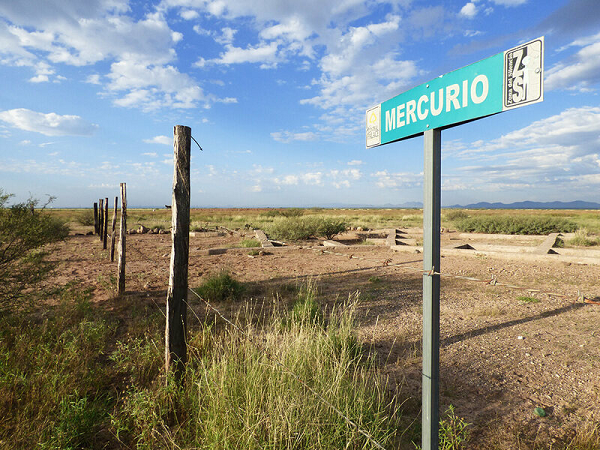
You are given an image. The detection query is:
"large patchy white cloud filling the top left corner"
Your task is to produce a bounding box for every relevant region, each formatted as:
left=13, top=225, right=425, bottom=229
left=0, top=4, right=232, bottom=111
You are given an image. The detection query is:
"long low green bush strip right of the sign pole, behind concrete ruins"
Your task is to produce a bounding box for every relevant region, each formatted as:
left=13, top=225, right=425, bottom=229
left=456, top=215, right=577, bottom=235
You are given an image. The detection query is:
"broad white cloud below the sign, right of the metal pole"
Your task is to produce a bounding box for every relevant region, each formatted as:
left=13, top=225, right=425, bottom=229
left=444, top=107, right=600, bottom=194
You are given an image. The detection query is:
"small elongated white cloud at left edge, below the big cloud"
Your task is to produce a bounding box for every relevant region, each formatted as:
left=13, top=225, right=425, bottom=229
left=0, top=108, right=98, bottom=136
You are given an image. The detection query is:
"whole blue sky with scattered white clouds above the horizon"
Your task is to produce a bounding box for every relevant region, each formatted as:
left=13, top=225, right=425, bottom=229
left=0, top=0, right=600, bottom=207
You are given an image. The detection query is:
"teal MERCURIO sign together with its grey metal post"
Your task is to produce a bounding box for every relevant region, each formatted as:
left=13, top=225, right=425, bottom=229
left=365, top=37, right=544, bottom=450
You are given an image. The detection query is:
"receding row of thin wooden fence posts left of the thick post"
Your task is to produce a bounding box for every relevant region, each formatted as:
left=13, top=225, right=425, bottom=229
left=94, top=183, right=127, bottom=295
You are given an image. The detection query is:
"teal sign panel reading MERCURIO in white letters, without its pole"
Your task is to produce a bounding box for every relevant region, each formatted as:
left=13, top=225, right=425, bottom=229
left=366, top=37, right=544, bottom=148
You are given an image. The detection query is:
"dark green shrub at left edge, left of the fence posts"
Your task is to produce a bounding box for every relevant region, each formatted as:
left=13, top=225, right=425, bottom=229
left=0, top=189, right=69, bottom=309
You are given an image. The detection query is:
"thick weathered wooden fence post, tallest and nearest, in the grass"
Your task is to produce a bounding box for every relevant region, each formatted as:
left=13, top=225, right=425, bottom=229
left=165, top=125, right=192, bottom=381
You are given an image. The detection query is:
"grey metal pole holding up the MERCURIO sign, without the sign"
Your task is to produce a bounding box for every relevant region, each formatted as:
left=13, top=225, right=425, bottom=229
left=421, top=129, right=442, bottom=450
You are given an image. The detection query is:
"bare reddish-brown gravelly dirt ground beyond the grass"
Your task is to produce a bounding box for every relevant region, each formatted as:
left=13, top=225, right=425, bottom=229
left=53, top=231, right=600, bottom=449
